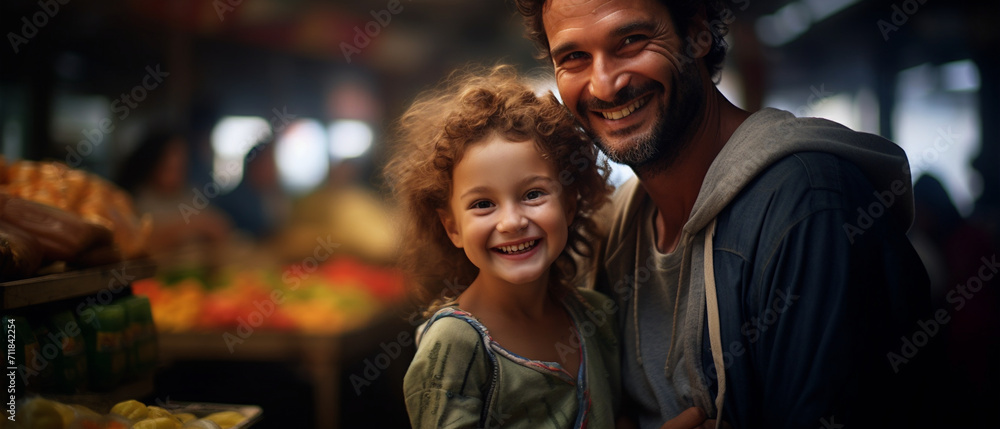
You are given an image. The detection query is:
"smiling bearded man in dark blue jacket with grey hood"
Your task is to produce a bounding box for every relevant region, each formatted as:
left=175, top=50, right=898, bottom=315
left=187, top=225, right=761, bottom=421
left=515, top=0, right=937, bottom=428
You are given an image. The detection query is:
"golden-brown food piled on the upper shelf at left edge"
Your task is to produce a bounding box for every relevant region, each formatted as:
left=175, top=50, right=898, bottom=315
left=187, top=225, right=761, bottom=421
left=0, top=157, right=152, bottom=281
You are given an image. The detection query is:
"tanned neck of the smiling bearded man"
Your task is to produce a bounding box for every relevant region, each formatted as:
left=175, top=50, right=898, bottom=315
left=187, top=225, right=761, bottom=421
left=636, top=85, right=750, bottom=252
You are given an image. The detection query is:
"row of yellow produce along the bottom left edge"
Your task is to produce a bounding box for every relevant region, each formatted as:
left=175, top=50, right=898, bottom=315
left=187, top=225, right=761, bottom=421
left=0, top=396, right=260, bottom=429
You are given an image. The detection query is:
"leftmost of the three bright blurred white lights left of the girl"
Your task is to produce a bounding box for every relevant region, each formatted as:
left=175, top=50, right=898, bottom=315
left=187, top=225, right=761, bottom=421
left=212, top=116, right=271, bottom=194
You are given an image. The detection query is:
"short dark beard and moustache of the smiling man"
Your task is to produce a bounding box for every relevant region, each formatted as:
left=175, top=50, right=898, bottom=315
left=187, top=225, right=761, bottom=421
left=577, top=65, right=704, bottom=173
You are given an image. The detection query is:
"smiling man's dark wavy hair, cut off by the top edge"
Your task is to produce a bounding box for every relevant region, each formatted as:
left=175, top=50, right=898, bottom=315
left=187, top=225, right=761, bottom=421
left=514, top=0, right=733, bottom=80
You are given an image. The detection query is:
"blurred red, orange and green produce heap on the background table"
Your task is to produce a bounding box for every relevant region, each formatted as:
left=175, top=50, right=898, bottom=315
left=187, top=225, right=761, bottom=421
left=132, top=257, right=405, bottom=333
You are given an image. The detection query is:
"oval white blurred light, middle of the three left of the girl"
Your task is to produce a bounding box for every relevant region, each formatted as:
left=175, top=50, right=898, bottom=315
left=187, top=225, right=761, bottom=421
left=274, top=119, right=330, bottom=194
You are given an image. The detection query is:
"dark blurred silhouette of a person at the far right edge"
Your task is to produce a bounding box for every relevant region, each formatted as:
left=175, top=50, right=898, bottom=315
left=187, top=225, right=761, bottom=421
left=910, top=173, right=1000, bottom=427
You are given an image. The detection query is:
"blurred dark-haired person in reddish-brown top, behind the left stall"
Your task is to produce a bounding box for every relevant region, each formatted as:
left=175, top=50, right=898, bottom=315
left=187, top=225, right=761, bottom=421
left=115, top=128, right=232, bottom=266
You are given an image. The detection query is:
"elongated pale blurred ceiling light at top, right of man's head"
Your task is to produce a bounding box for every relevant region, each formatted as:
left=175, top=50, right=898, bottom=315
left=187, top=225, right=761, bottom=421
left=754, top=0, right=858, bottom=46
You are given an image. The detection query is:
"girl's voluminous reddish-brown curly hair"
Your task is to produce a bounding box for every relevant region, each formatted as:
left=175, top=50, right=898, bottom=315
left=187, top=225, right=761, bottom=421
left=385, top=65, right=613, bottom=317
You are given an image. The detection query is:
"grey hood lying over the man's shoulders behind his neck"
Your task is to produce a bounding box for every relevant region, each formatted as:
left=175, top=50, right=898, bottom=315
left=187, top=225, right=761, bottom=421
left=684, top=108, right=914, bottom=236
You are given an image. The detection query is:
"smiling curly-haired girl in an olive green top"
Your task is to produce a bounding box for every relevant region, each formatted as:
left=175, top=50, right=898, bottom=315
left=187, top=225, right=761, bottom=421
left=386, top=65, right=620, bottom=428
